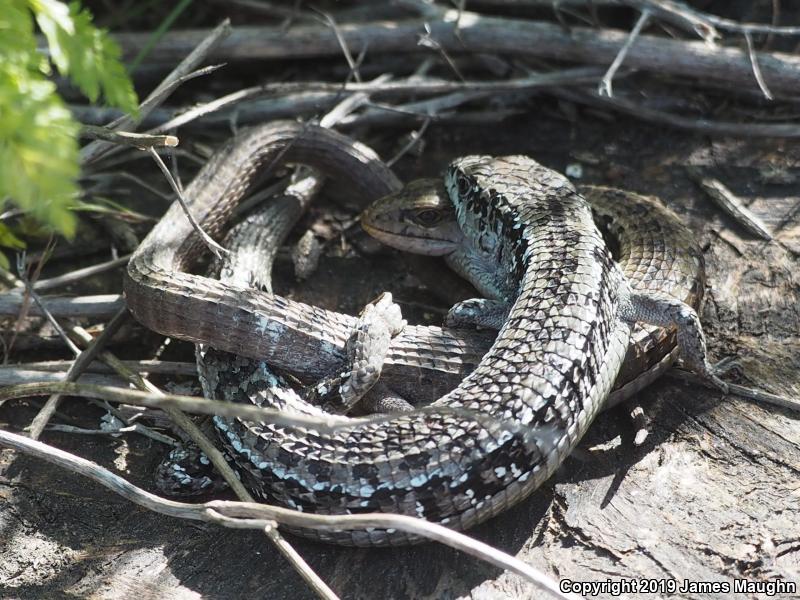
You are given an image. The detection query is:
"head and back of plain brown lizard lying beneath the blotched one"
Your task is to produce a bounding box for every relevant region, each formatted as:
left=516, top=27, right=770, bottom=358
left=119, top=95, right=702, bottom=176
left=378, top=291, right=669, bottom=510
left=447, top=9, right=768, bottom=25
left=361, top=179, right=705, bottom=406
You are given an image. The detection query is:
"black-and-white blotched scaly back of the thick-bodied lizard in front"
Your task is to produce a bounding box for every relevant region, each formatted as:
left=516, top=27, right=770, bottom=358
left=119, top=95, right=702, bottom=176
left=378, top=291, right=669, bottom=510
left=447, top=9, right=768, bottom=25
left=200, top=157, right=630, bottom=545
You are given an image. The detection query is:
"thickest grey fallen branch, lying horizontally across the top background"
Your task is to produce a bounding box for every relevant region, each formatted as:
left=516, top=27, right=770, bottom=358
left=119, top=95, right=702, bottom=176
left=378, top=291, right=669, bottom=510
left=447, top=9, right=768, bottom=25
left=116, top=10, right=800, bottom=94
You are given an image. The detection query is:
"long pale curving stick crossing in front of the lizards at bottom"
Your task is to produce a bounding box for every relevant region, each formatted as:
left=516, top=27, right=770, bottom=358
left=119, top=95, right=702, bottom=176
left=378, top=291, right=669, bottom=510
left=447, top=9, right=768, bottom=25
left=0, top=430, right=579, bottom=600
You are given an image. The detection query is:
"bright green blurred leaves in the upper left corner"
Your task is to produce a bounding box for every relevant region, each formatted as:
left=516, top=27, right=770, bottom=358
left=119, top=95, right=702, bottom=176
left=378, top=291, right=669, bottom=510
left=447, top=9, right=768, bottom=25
left=0, top=0, right=137, bottom=246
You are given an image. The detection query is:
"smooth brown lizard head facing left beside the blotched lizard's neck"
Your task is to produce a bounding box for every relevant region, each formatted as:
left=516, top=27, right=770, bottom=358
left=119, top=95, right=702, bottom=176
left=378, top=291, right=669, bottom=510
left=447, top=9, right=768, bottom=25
left=361, top=179, right=464, bottom=256
